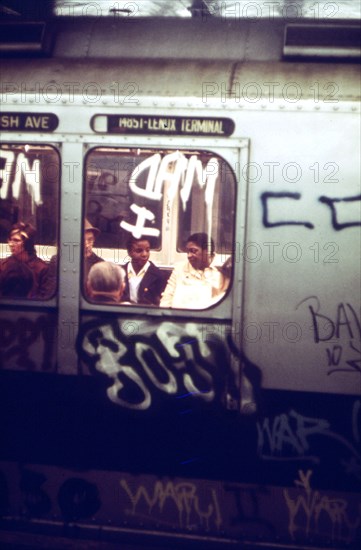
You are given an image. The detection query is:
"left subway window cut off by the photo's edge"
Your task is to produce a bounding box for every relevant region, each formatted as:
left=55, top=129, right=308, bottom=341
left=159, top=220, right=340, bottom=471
left=0, top=143, right=60, bottom=300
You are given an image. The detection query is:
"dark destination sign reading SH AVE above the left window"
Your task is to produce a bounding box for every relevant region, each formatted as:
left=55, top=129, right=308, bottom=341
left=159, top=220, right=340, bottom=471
left=0, top=113, right=59, bottom=132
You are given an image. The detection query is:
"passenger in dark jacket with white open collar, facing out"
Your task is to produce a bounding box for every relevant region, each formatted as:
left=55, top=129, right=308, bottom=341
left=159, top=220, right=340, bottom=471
left=124, top=237, right=165, bottom=306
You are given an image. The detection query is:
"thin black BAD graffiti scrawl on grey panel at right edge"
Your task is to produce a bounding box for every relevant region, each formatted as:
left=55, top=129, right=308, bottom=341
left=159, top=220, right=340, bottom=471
left=296, top=296, right=361, bottom=375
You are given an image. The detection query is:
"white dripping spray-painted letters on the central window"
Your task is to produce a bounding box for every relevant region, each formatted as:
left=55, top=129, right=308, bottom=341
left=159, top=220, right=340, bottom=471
left=120, top=151, right=219, bottom=238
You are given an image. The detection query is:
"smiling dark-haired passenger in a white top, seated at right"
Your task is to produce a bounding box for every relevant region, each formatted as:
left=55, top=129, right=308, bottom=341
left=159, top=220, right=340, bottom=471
left=160, top=233, right=223, bottom=309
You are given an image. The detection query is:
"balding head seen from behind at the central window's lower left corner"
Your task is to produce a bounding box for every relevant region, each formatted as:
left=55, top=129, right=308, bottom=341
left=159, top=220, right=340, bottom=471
left=87, top=261, right=125, bottom=304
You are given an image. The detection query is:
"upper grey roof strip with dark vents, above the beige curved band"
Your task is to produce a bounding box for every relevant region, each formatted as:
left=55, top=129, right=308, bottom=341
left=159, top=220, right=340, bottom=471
left=0, top=17, right=361, bottom=62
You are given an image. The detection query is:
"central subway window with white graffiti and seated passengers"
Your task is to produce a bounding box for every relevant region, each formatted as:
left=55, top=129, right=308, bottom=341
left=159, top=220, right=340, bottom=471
left=83, top=147, right=236, bottom=309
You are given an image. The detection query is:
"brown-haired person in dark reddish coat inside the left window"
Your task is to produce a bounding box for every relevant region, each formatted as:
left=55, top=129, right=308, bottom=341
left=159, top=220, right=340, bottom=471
left=0, top=222, right=52, bottom=300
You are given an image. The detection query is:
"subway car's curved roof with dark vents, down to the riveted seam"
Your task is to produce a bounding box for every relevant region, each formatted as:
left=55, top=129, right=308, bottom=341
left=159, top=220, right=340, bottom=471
left=0, top=17, right=360, bottom=101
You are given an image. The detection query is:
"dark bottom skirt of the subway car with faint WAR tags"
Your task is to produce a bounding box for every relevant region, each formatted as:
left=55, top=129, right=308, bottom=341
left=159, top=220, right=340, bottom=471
left=0, top=462, right=361, bottom=548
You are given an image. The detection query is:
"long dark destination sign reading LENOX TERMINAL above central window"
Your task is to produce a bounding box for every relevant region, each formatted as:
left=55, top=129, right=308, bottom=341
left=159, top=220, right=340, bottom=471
left=92, top=115, right=235, bottom=137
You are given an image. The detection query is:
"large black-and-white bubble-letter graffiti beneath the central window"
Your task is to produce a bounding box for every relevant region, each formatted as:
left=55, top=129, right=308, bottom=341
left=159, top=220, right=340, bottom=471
left=76, top=320, right=262, bottom=414
